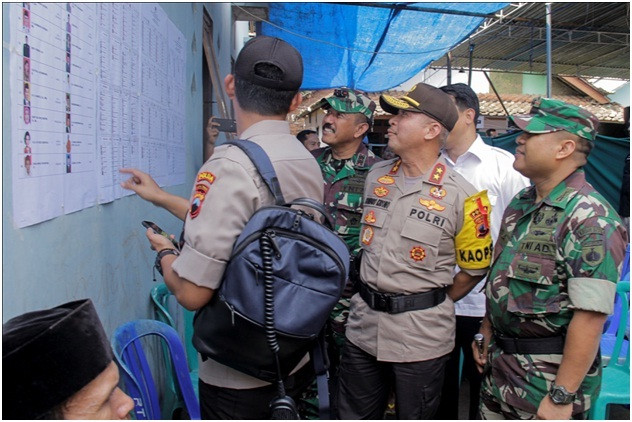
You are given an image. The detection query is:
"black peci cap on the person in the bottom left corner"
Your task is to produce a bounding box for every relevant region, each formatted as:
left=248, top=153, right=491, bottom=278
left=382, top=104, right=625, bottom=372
left=2, top=299, right=113, bottom=419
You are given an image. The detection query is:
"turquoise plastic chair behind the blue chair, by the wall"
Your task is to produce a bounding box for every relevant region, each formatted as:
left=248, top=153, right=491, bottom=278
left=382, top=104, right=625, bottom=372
left=151, top=283, right=199, bottom=397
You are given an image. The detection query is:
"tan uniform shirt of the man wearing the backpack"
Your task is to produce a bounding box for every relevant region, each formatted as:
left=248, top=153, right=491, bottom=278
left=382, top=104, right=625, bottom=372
left=173, top=120, right=323, bottom=389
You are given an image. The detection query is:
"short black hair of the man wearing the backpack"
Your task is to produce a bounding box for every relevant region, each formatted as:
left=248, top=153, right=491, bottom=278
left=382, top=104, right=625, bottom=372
left=234, top=63, right=298, bottom=116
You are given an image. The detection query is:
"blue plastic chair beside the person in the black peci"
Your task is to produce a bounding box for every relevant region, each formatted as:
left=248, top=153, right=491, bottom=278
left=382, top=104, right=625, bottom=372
left=112, top=319, right=200, bottom=420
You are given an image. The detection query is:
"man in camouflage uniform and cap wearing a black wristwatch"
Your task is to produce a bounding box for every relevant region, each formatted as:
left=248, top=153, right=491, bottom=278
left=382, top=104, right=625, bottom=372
left=472, top=99, right=627, bottom=419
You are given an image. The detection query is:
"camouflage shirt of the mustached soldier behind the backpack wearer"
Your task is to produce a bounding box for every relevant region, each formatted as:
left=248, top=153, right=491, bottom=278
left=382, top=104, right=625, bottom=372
left=312, top=143, right=382, bottom=255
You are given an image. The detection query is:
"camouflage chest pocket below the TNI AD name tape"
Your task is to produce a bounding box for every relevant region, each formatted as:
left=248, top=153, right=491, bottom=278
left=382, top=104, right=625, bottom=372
left=507, top=255, right=561, bottom=317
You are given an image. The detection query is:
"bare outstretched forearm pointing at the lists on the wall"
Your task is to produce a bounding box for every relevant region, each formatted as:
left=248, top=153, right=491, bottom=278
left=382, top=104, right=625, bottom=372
left=119, top=168, right=189, bottom=221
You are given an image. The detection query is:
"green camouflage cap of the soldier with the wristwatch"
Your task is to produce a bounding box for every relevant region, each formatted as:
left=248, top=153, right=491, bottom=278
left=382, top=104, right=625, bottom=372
left=511, top=98, right=599, bottom=142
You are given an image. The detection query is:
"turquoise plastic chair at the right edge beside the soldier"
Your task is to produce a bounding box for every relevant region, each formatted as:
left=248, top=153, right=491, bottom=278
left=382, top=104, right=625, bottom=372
left=590, top=281, right=630, bottom=419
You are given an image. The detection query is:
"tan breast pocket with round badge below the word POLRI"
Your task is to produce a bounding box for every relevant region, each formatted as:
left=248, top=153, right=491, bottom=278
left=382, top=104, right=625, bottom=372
left=393, top=219, right=443, bottom=271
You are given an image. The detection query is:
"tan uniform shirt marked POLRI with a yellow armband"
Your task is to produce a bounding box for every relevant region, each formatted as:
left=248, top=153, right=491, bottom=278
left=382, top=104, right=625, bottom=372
left=346, top=158, right=492, bottom=362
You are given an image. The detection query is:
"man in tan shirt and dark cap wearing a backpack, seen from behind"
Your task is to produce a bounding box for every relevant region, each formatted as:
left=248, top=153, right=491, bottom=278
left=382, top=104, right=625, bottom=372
left=147, top=36, right=323, bottom=419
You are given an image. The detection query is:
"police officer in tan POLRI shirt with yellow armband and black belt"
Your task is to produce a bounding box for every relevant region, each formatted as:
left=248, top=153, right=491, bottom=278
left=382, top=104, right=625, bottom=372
left=338, top=84, right=492, bottom=419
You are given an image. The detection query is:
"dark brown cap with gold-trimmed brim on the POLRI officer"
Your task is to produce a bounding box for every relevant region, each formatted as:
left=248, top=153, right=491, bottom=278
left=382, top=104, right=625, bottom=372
left=380, top=83, right=459, bottom=130
